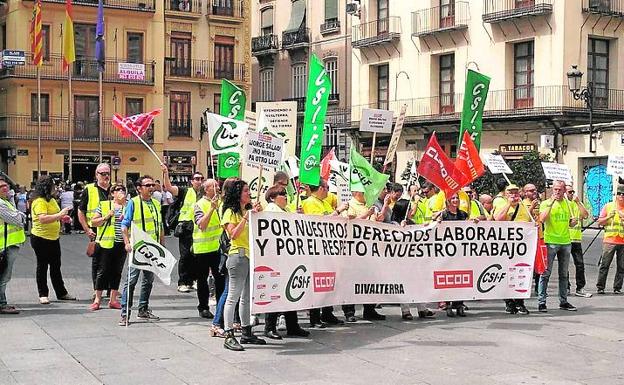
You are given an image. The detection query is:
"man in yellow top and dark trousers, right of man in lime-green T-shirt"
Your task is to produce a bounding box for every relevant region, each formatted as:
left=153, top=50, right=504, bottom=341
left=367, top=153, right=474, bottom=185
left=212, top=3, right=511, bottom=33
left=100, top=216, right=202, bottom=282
left=566, top=185, right=592, bottom=298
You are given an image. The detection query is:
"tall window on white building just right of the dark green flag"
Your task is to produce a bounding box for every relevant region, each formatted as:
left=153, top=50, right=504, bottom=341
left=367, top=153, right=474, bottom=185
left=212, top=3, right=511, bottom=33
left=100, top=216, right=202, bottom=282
left=514, top=41, right=534, bottom=108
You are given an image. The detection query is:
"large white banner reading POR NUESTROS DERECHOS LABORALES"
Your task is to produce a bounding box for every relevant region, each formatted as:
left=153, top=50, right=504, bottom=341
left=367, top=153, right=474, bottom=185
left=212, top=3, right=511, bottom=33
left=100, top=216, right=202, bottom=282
left=250, top=212, right=537, bottom=313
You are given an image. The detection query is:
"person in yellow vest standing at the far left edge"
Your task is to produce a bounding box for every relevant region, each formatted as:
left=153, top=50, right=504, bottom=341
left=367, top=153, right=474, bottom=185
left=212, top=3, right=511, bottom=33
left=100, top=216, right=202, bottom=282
left=0, top=178, right=26, bottom=314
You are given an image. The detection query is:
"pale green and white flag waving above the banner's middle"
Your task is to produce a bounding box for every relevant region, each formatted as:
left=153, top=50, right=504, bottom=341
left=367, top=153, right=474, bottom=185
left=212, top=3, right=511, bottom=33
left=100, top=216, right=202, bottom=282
left=349, top=146, right=390, bottom=206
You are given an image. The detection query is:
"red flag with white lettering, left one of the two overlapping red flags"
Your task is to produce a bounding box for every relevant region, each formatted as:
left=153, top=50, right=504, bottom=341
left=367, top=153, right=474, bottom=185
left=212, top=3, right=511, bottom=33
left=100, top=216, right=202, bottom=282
left=418, top=133, right=468, bottom=198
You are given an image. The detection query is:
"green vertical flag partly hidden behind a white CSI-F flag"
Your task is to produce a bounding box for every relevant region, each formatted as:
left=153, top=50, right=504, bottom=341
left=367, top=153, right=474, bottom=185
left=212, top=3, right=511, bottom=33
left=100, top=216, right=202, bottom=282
left=217, top=79, right=247, bottom=178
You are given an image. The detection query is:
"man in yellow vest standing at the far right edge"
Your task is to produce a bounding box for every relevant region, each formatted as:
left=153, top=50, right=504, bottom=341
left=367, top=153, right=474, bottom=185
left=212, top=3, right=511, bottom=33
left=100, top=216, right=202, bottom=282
left=596, top=184, right=624, bottom=294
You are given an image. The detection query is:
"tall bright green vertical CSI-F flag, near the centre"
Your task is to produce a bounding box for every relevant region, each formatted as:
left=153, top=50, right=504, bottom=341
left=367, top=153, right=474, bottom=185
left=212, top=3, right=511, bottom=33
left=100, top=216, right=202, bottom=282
left=299, top=54, right=331, bottom=186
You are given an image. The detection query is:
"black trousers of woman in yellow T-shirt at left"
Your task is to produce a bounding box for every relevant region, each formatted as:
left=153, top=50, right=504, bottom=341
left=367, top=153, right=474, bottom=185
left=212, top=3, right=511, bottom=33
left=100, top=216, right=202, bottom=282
left=30, top=234, right=67, bottom=298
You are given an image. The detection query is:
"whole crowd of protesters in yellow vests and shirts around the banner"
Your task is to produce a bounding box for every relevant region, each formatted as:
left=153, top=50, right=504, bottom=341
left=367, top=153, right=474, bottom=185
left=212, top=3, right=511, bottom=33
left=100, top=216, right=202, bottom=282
left=0, top=163, right=624, bottom=351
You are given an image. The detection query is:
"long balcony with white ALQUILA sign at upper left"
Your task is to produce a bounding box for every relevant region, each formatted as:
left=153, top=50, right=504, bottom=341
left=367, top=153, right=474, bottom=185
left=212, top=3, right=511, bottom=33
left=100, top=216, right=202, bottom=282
left=0, top=53, right=154, bottom=86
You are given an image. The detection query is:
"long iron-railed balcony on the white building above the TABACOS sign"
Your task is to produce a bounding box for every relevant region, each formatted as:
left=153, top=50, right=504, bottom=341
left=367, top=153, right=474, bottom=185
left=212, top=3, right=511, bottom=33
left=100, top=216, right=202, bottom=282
left=352, top=85, right=624, bottom=123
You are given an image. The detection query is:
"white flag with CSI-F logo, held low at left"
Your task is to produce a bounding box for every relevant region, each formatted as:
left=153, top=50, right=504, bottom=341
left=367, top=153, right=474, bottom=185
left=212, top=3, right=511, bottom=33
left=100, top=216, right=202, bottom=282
left=128, top=223, right=177, bottom=285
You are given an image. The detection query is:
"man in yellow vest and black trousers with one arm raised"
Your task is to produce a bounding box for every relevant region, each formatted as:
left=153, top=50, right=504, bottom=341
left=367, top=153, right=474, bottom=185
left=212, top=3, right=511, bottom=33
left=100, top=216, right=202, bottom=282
left=161, top=165, right=204, bottom=293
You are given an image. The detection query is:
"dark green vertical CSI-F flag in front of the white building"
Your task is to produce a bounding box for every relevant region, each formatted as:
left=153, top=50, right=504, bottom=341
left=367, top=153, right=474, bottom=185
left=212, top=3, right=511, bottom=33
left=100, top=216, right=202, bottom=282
left=457, top=70, right=490, bottom=149
